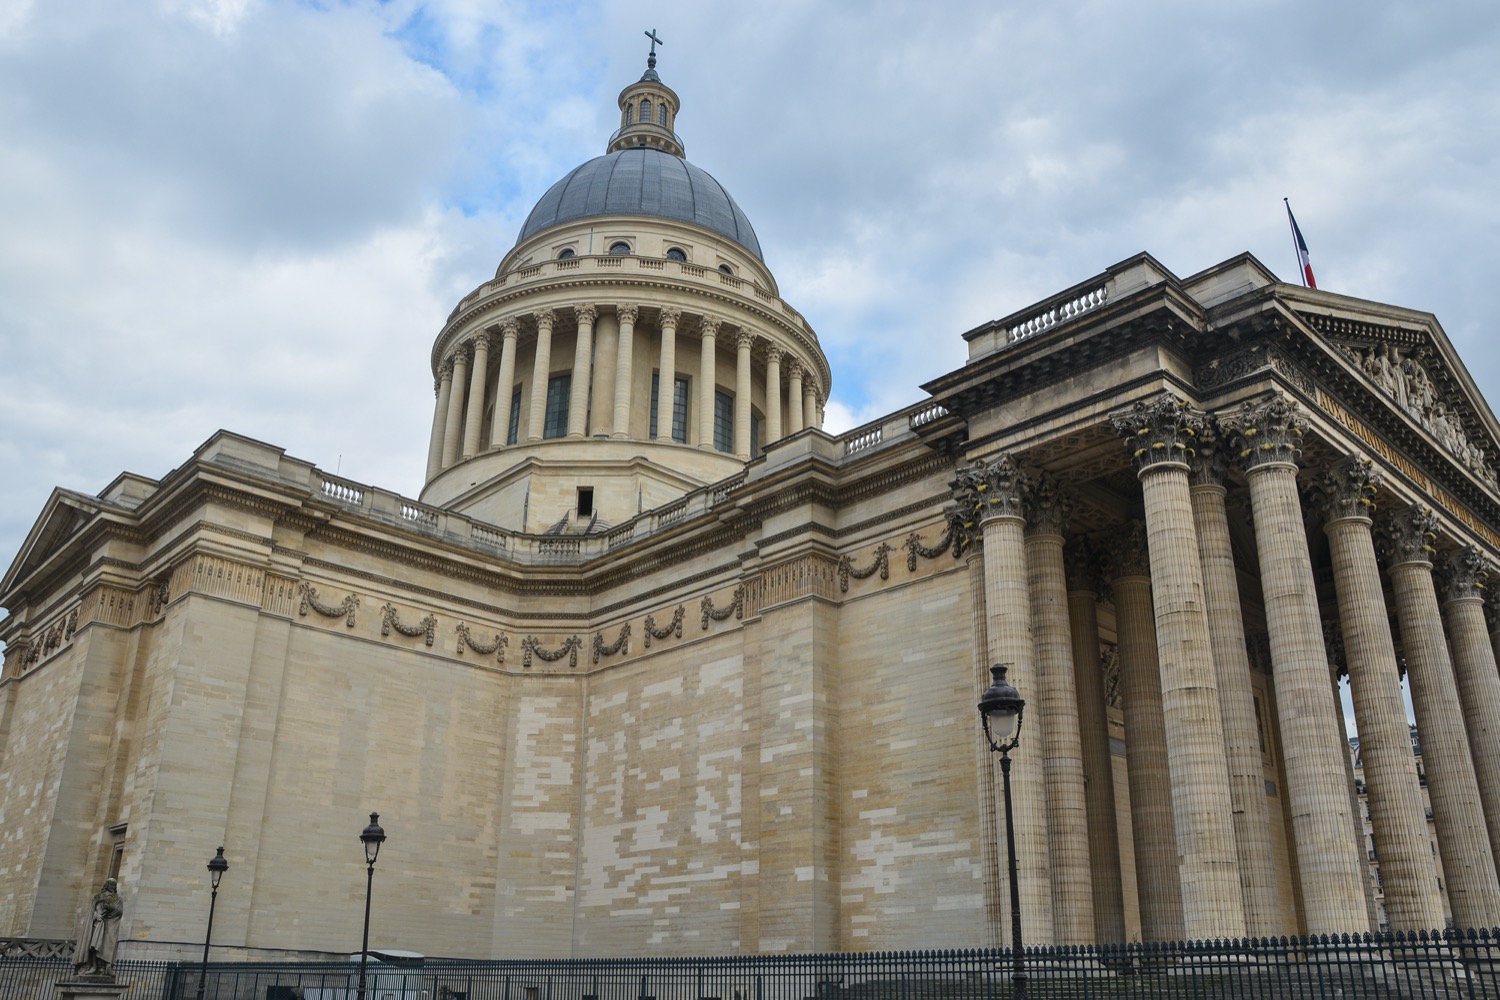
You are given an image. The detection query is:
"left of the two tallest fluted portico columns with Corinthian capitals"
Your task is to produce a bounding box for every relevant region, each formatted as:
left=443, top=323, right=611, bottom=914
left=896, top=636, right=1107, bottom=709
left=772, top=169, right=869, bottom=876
left=1112, top=396, right=1245, bottom=940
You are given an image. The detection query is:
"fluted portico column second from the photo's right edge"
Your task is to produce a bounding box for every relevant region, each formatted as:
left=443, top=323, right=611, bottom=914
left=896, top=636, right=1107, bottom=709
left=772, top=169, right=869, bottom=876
left=1385, top=507, right=1500, bottom=930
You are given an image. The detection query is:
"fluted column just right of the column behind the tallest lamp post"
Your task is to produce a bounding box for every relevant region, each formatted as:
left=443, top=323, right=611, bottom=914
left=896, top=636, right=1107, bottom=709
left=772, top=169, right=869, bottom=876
left=1022, top=474, right=1094, bottom=945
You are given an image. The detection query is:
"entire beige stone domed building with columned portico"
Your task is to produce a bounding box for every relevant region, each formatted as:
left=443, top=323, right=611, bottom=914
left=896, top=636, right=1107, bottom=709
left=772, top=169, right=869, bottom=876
left=0, top=54, right=1500, bottom=957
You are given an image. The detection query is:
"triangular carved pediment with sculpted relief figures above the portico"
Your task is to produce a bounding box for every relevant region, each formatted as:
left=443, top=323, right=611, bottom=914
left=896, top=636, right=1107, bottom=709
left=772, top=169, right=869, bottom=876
left=1299, top=310, right=1500, bottom=492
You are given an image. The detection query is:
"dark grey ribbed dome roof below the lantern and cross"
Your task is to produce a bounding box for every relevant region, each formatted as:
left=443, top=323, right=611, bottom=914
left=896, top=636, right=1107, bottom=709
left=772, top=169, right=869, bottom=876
left=516, top=148, right=765, bottom=261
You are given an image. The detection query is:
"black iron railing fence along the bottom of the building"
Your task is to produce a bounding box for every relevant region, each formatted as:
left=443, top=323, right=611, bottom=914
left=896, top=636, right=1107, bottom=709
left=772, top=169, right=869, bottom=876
left=0, top=931, right=1500, bottom=1000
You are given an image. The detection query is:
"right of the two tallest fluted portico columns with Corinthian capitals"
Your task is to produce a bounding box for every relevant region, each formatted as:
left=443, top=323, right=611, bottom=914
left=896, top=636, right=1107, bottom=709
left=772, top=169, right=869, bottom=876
left=1220, top=396, right=1370, bottom=934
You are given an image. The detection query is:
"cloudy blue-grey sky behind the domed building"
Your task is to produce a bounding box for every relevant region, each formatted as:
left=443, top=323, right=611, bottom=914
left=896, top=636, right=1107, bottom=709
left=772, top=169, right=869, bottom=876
left=0, top=0, right=1500, bottom=593
